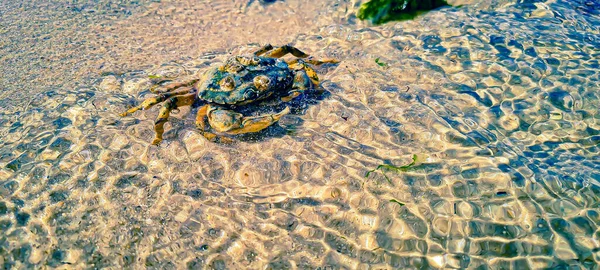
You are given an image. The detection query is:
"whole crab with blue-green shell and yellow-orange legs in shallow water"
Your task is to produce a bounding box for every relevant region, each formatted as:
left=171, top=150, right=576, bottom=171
left=120, top=44, right=339, bottom=145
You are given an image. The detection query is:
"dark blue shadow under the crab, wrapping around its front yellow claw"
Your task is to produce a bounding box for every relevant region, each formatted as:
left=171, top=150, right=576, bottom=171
left=202, top=87, right=331, bottom=142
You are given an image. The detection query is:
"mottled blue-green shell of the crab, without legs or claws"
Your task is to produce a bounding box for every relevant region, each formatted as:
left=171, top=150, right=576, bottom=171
left=197, top=56, right=294, bottom=105
